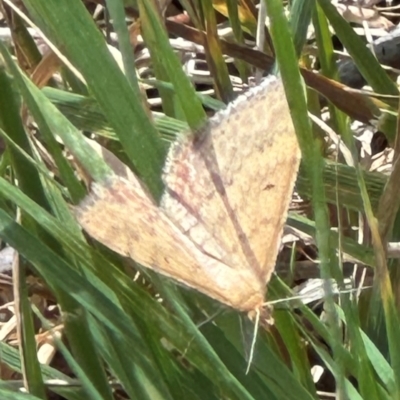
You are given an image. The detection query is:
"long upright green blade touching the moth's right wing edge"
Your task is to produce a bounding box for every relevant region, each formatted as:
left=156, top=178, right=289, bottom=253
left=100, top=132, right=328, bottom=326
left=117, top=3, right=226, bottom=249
left=266, top=0, right=346, bottom=396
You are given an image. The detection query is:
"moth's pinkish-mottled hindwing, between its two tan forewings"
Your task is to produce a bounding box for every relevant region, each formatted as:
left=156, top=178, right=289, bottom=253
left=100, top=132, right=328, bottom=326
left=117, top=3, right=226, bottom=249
left=161, top=135, right=248, bottom=269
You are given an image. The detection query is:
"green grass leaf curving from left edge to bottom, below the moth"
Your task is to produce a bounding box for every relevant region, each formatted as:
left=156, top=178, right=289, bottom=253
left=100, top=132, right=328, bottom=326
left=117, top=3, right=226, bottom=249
left=0, top=210, right=175, bottom=399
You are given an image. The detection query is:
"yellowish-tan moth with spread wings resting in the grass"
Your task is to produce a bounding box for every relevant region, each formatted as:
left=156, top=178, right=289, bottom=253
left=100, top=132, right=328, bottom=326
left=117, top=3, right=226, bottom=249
left=76, top=76, right=300, bottom=312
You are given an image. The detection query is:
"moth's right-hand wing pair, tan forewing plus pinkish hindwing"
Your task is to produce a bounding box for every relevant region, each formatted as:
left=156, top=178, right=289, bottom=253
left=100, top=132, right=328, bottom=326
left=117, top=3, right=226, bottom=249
left=161, top=78, right=300, bottom=282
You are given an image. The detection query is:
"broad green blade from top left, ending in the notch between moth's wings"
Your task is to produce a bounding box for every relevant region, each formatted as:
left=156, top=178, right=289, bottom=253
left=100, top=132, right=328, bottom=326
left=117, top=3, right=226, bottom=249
left=24, top=0, right=166, bottom=198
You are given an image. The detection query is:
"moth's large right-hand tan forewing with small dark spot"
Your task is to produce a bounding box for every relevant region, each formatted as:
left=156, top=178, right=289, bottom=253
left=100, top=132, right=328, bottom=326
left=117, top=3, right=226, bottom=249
left=213, top=80, right=300, bottom=282
